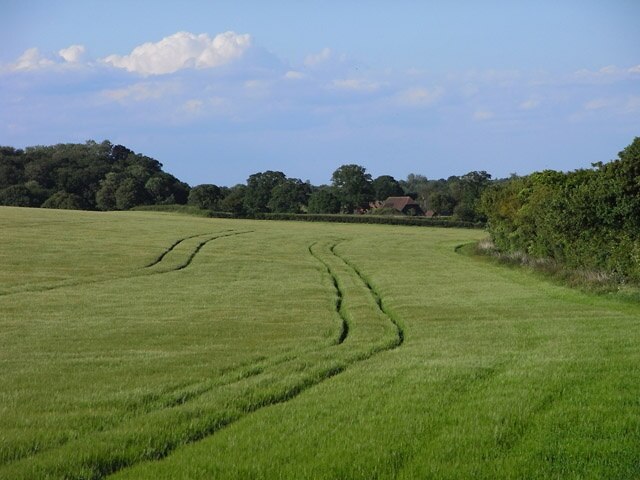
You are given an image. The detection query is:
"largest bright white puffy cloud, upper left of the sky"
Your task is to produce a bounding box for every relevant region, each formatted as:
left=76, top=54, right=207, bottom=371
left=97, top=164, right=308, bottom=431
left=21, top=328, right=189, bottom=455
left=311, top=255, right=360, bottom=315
left=103, top=32, right=251, bottom=75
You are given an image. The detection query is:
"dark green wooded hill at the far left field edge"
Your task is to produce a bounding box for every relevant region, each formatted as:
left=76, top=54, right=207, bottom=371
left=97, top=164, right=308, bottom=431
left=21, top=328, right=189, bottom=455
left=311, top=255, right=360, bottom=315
left=0, top=140, right=189, bottom=210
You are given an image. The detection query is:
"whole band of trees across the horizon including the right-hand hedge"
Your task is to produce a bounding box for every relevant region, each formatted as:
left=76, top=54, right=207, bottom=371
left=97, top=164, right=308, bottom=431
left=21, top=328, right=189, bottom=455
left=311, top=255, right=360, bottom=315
left=0, top=138, right=640, bottom=282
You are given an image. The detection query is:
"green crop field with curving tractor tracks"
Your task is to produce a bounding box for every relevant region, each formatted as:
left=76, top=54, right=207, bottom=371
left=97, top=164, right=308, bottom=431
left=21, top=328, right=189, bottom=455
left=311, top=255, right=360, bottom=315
left=0, top=207, right=640, bottom=479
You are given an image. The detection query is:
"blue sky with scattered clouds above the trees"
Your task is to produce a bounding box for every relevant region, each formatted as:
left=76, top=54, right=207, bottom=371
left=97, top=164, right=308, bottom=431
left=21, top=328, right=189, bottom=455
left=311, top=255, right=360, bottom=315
left=0, top=0, right=640, bottom=186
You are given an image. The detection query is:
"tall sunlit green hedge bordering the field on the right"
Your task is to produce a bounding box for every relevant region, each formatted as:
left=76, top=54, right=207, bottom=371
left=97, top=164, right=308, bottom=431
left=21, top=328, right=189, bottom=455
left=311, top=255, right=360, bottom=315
left=479, top=137, right=640, bottom=282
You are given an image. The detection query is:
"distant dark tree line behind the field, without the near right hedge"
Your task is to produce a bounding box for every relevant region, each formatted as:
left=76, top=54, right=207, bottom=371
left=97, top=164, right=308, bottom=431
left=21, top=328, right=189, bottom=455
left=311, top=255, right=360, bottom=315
left=0, top=140, right=491, bottom=222
